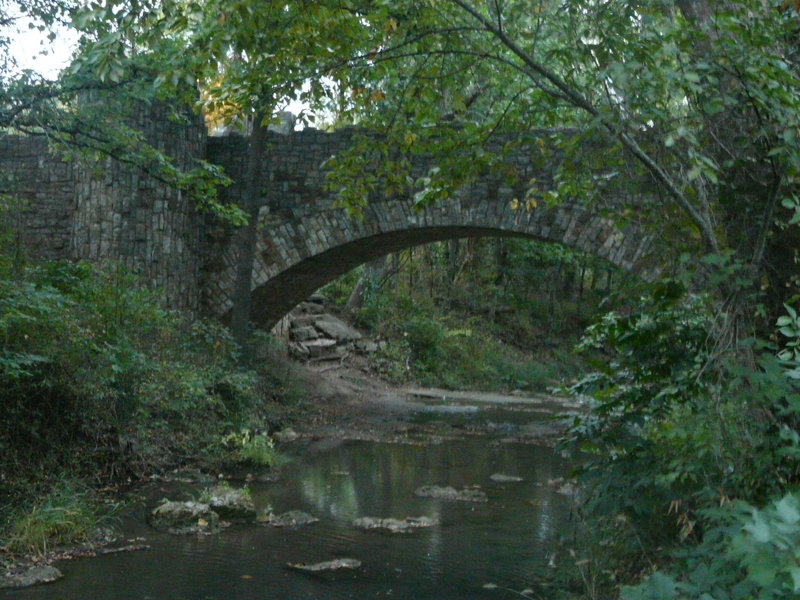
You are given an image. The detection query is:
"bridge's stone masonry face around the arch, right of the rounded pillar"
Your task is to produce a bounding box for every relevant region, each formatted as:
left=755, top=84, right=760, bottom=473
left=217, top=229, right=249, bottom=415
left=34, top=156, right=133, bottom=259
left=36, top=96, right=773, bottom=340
left=208, top=130, right=658, bottom=327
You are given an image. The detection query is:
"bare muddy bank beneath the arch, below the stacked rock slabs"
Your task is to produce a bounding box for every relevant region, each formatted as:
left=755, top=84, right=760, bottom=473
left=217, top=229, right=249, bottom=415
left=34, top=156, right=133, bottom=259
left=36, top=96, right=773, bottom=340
left=291, top=361, right=581, bottom=445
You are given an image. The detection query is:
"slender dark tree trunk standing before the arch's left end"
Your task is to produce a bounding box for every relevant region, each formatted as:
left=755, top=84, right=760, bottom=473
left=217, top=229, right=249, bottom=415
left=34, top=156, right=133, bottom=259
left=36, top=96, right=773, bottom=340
left=231, top=113, right=267, bottom=349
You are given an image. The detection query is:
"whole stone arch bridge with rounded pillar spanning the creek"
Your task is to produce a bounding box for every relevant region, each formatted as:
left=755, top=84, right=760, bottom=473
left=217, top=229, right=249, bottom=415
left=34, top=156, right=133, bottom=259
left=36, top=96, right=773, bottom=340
left=0, top=105, right=659, bottom=327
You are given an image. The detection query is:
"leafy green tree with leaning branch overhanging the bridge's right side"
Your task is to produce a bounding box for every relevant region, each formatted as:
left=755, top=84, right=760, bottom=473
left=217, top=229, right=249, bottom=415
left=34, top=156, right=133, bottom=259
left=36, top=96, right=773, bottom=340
left=318, top=0, right=800, bottom=324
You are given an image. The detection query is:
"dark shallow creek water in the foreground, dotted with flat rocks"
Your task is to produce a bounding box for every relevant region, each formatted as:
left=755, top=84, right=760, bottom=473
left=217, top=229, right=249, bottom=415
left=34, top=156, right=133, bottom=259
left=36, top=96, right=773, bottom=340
left=2, top=409, right=569, bottom=600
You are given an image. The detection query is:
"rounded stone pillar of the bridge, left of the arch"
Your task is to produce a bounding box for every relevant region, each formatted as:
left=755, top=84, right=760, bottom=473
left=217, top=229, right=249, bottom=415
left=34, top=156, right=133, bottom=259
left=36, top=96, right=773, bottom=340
left=70, top=103, right=206, bottom=314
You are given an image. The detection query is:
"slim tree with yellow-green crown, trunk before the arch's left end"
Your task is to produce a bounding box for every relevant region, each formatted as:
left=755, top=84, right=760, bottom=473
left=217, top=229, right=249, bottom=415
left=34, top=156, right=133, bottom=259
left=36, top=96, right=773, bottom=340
left=71, top=0, right=388, bottom=345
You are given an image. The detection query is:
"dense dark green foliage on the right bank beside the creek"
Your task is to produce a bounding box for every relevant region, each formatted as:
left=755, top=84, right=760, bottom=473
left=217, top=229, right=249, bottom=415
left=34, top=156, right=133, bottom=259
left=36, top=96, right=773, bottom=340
left=565, top=283, right=800, bottom=598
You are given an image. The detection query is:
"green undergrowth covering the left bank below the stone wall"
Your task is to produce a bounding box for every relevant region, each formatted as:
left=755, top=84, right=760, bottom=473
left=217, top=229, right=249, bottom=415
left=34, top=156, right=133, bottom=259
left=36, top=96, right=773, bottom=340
left=0, top=254, right=300, bottom=552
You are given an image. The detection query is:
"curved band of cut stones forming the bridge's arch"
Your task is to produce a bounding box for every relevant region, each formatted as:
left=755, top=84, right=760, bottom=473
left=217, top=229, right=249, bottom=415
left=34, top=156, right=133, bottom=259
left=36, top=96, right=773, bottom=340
left=209, top=194, right=656, bottom=329
